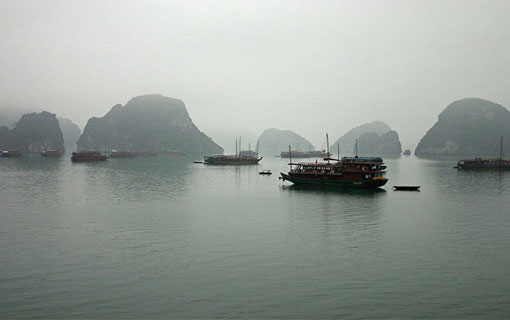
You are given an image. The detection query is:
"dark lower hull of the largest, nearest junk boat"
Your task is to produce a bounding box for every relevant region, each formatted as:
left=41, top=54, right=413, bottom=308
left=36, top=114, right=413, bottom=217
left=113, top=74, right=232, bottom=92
left=280, top=172, right=388, bottom=189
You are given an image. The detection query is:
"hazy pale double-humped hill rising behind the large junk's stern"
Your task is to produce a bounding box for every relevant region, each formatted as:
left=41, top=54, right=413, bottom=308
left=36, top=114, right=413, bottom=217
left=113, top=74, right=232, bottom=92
left=331, top=121, right=402, bottom=156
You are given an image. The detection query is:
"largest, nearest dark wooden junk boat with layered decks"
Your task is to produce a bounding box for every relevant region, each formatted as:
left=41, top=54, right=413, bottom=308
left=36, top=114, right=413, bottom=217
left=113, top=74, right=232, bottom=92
left=279, top=136, right=388, bottom=188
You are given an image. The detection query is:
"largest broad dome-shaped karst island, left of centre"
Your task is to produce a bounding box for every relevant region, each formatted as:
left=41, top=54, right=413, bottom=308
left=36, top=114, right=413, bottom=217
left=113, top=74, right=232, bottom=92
left=77, top=94, right=223, bottom=154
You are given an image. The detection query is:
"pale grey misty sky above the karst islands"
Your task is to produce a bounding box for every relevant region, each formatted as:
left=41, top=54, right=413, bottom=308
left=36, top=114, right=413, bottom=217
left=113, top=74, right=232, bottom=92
left=0, top=0, right=510, bottom=148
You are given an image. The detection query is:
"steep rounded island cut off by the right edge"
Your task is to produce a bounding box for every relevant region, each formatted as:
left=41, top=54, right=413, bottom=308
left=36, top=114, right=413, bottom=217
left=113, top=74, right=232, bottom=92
left=415, top=98, right=510, bottom=156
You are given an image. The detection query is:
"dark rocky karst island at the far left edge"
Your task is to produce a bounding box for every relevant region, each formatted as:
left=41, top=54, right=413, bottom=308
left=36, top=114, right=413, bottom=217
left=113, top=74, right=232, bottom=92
left=0, top=111, right=64, bottom=152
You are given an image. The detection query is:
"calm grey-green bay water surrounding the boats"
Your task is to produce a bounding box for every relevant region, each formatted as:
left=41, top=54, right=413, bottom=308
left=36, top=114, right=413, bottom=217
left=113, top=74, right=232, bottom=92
left=0, top=156, right=510, bottom=318
